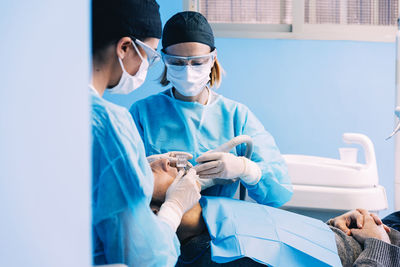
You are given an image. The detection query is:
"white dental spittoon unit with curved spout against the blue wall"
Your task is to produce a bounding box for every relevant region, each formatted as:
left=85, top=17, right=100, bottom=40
left=282, top=133, right=388, bottom=221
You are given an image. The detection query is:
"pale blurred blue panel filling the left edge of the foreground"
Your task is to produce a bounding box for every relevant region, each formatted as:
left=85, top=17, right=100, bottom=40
left=0, top=0, right=91, bottom=267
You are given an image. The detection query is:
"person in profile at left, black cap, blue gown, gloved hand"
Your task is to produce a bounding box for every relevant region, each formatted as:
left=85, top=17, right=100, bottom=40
left=90, top=0, right=200, bottom=266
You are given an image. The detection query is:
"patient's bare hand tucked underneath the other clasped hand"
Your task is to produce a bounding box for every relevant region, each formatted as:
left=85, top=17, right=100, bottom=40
left=328, top=209, right=390, bottom=235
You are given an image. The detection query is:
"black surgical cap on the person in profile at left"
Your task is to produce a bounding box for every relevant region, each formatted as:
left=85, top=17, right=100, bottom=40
left=92, top=0, right=161, bottom=53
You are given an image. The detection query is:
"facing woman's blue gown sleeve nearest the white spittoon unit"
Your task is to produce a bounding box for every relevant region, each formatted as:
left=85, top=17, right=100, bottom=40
left=240, top=109, right=293, bottom=207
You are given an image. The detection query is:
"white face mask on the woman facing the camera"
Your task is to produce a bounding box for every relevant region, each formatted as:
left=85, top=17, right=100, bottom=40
left=167, top=64, right=211, bottom=96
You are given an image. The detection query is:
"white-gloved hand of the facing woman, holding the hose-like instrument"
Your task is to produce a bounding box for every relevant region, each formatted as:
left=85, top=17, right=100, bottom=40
left=194, top=152, right=261, bottom=185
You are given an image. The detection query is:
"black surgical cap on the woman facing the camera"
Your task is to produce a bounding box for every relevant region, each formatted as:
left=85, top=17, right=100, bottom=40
left=162, top=11, right=215, bottom=50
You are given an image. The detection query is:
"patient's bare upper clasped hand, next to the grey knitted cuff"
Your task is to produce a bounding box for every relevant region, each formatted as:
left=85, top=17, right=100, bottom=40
left=351, top=210, right=391, bottom=245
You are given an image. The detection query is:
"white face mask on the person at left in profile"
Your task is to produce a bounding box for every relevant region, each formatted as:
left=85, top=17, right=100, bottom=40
left=108, top=42, right=149, bottom=94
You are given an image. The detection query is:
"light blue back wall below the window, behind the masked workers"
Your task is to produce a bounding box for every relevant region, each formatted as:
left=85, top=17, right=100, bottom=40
left=107, top=0, right=395, bottom=218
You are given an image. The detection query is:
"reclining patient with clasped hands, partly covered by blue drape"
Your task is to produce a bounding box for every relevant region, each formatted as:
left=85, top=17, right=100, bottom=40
left=150, top=159, right=400, bottom=266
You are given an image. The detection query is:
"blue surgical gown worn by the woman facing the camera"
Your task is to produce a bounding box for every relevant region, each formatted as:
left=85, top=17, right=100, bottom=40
left=130, top=89, right=292, bottom=207
